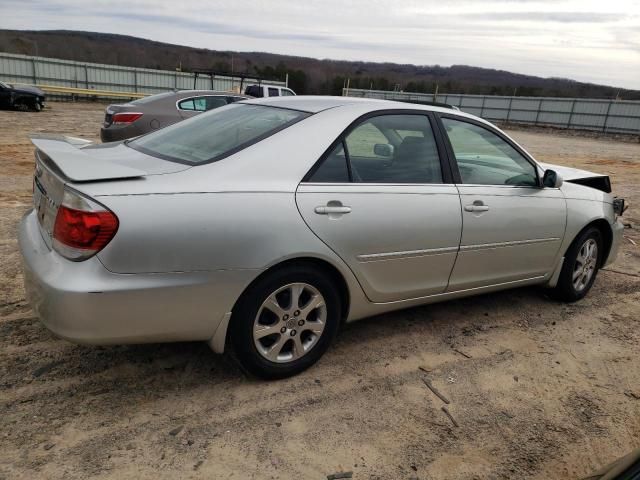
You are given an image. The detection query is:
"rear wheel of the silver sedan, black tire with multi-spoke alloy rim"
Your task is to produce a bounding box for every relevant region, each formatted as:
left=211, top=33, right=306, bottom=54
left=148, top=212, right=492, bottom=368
left=230, top=265, right=342, bottom=379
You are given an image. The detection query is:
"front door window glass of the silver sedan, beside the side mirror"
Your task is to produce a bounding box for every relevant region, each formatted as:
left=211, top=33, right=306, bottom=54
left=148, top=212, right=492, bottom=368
left=442, top=118, right=538, bottom=187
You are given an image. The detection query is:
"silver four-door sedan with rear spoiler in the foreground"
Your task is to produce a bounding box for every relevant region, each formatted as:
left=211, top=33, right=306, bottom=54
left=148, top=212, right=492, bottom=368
left=19, top=97, right=624, bottom=378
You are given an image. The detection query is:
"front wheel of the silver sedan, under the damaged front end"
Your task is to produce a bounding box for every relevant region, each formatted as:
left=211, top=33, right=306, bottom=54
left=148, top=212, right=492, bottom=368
left=551, top=227, right=604, bottom=302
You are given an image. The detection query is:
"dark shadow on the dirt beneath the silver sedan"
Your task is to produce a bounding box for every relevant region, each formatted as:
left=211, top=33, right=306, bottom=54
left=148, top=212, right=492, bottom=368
left=2, top=288, right=557, bottom=400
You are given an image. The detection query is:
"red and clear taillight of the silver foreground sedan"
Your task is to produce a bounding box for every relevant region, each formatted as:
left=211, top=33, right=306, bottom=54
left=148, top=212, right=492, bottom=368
left=53, top=189, right=118, bottom=262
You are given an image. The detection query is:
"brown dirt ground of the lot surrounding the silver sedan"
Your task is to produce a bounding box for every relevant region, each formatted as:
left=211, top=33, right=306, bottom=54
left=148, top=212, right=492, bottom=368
left=0, top=103, right=640, bottom=480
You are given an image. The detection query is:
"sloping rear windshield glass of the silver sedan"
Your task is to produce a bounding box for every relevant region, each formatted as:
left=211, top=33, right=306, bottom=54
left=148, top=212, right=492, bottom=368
left=127, top=103, right=310, bottom=165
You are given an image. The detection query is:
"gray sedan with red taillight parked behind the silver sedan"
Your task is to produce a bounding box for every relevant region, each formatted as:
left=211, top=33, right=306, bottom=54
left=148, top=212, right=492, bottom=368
left=100, top=90, right=251, bottom=142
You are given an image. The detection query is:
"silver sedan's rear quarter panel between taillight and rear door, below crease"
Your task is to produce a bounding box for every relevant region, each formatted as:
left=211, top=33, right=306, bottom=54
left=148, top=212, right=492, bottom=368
left=97, top=192, right=368, bottom=317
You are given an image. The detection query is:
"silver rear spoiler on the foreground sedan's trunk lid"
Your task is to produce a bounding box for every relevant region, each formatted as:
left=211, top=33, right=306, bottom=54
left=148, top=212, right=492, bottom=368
left=31, top=135, right=146, bottom=182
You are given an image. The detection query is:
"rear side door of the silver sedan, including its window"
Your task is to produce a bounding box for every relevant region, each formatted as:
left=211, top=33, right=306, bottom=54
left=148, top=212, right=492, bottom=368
left=296, top=111, right=462, bottom=302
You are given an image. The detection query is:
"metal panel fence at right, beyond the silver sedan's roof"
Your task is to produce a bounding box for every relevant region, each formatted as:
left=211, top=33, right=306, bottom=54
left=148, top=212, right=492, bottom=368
left=342, top=88, right=640, bottom=135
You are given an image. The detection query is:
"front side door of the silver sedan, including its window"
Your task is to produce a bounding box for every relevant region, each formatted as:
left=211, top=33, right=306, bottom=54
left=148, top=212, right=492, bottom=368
left=441, top=115, right=566, bottom=291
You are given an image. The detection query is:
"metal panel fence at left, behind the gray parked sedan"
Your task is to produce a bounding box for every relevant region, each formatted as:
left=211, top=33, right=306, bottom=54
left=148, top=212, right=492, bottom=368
left=0, top=53, right=284, bottom=96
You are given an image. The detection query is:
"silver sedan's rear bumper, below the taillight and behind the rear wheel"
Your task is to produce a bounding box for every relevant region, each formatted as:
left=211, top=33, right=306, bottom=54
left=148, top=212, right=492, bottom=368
left=19, top=212, right=259, bottom=344
